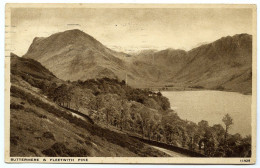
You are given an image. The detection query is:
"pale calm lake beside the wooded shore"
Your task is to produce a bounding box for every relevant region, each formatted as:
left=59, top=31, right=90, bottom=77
left=162, top=91, right=252, bottom=136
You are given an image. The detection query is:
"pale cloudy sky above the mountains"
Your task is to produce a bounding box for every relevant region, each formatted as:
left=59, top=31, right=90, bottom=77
left=10, top=8, right=253, bottom=56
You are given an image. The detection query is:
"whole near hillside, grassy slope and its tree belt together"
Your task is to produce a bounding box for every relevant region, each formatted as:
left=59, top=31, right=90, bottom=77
left=10, top=54, right=251, bottom=157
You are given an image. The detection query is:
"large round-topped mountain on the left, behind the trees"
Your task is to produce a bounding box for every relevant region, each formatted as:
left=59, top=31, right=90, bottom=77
left=23, top=30, right=128, bottom=80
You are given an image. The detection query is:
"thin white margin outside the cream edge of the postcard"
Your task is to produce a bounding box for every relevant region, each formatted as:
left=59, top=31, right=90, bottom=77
left=0, top=0, right=260, bottom=167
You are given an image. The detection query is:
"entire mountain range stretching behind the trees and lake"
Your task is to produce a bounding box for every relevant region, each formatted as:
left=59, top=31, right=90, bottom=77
left=23, top=30, right=252, bottom=93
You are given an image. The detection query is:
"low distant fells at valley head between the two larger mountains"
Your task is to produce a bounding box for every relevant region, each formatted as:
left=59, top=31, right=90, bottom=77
left=128, top=49, right=187, bottom=87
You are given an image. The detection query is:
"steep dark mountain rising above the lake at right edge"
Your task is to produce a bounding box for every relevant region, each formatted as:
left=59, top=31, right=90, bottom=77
left=172, top=34, right=252, bottom=93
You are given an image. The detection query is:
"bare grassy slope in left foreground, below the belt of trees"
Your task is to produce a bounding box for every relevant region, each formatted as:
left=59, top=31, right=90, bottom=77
left=10, top=56, right=167, bottom=157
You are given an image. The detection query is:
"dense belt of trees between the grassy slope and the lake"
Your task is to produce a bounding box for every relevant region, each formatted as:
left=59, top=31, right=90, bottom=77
left=17, top=75, right=251, bottom=157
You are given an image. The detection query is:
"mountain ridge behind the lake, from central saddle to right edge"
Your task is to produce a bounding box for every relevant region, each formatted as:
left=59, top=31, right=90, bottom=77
left=133, top=34, right=252, bottom=94
